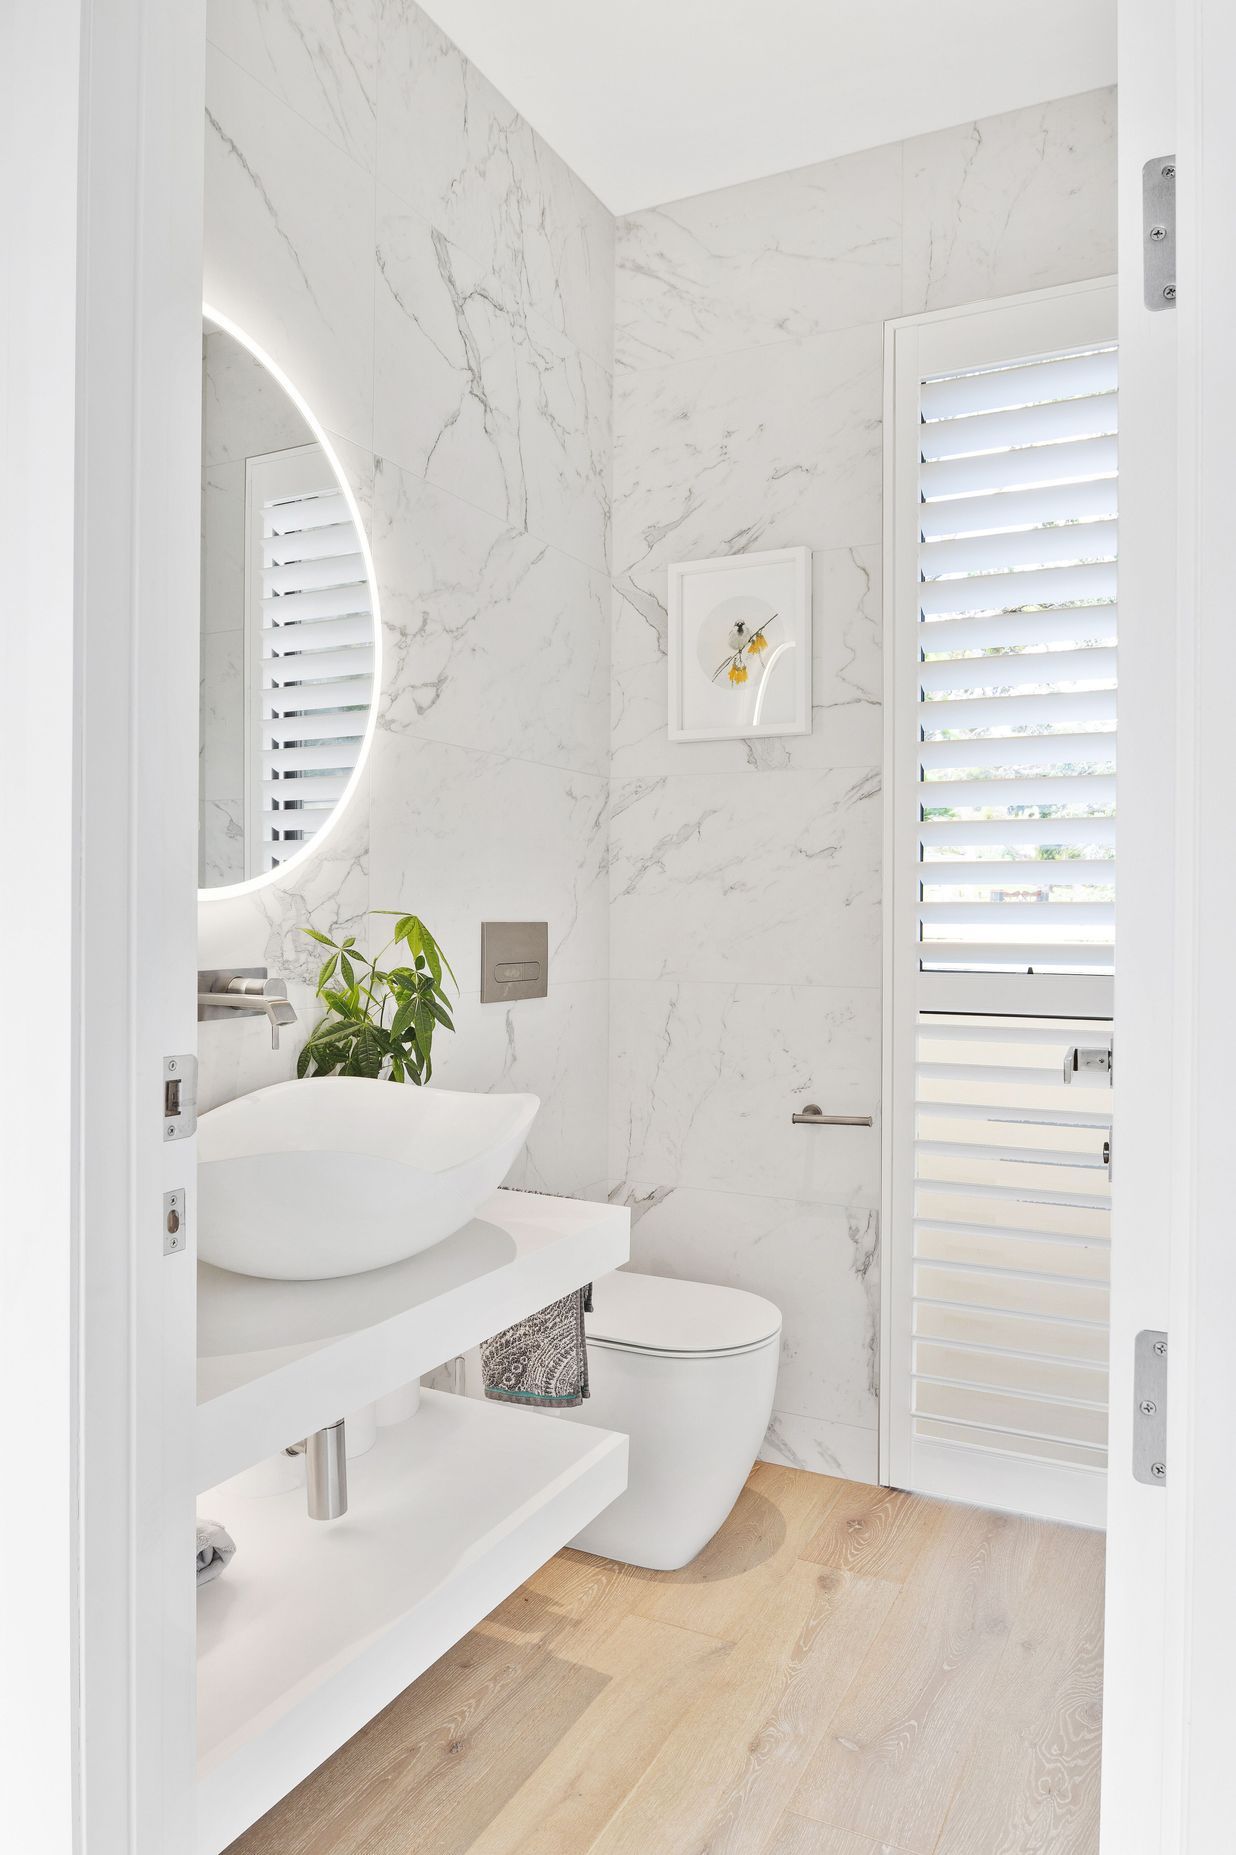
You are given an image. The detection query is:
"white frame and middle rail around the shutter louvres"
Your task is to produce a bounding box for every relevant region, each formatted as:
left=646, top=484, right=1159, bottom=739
left=880, top=276, right=1115, bottom=1519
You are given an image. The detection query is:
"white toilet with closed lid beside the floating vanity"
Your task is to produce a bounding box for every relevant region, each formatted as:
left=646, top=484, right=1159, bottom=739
left=562, top=1269, right=781, bottom=1571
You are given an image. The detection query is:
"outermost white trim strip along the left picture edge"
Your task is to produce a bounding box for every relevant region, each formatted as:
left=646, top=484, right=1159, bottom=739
left=0, top=0, right=82, bottom=1855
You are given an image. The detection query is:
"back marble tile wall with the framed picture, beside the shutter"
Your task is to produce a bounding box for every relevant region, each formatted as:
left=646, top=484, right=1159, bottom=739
left=609, top=91, right=1115, bottom=1480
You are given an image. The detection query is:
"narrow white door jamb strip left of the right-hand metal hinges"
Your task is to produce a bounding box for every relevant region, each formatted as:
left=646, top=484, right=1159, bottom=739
left=1101, top=0, right=1172, bottom=1855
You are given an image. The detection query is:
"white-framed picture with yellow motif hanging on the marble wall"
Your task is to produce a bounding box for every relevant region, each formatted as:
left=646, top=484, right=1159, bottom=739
left=668, top=547, right=811, bottom=740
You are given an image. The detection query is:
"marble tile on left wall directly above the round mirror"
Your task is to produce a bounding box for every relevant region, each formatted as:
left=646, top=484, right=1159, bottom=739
left=204, top=46, right=373, bottom=447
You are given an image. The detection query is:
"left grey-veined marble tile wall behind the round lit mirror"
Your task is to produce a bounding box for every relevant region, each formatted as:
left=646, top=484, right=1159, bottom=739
left=200, top=0, right=614, bottom=1191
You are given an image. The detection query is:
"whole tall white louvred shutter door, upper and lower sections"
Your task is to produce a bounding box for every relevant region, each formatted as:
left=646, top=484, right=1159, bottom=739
left=883, top=286, right=1117, bottom=1525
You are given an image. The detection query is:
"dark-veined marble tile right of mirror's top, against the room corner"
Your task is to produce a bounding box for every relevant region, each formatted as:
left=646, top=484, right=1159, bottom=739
left=375, top=191, right=611, bottom=569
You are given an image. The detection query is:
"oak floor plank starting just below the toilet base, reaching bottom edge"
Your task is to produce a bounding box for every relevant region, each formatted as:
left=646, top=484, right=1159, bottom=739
left=468, top=1616, right=733, bottom=1855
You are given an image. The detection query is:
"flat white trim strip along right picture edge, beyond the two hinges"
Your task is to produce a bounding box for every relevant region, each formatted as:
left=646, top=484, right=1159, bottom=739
left=1158, top=0, right=1236, bottom=1855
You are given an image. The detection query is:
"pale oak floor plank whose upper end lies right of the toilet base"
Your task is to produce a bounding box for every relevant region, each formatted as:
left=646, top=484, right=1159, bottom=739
left=590, top=1560, right=898, bottom=1855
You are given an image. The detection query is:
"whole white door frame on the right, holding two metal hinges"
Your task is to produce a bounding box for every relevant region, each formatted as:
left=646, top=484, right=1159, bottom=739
left=1101, top=0, right=1236, bottom=1855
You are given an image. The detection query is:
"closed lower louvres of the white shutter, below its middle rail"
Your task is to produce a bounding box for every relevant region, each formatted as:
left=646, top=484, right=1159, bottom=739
left=909, top=1013, right=1112, bottom=1517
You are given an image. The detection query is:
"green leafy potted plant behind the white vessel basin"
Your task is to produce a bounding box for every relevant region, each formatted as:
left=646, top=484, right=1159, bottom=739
left=297, top=909, right=458, bottom=1083
